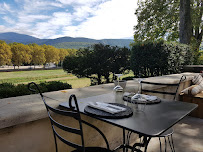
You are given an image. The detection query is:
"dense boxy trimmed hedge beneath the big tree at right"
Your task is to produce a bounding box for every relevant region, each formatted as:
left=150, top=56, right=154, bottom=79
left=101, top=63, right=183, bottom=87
left=131, top=41, right=193, bottom=77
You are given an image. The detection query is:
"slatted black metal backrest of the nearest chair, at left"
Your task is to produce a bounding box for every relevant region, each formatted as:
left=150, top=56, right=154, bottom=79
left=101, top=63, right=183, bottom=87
left=28, top=82, right=85, bottom=152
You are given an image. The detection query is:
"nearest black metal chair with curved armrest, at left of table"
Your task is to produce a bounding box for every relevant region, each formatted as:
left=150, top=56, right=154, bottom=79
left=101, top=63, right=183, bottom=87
left=28, top=82, right=112, bottom=152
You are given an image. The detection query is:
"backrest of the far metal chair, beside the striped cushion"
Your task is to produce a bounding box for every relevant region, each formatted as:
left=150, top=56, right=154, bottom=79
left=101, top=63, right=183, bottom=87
left=141, top=75, right=186, bottom=100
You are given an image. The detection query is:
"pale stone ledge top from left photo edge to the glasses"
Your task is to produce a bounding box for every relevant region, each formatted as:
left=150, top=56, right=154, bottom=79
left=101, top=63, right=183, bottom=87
left=0, top=83, right=114, bottom=129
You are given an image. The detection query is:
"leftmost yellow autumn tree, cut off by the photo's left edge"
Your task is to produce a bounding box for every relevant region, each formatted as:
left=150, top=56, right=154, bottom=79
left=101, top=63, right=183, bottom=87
left=0, top=41, right=12, bottom=66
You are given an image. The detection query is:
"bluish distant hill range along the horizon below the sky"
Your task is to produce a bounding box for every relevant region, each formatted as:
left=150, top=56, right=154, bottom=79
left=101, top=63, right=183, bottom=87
left=0, top=32, right=133, bottom=49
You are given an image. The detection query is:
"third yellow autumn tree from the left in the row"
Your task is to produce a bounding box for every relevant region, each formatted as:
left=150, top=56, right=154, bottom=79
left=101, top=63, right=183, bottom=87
left=29, top=44, right=46, bottom=67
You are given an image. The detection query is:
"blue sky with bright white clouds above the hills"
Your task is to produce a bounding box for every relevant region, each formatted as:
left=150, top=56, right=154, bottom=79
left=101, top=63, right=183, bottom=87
left=0, top=0, right=137, bottom=39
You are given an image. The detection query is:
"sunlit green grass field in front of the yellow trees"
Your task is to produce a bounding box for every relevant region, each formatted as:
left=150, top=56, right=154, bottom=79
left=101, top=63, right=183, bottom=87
left=0, top=69, right=135, bottom=88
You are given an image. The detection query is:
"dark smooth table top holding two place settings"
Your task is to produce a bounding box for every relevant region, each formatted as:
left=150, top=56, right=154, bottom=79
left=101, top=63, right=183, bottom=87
left=60, top=93, right=197, bottom=137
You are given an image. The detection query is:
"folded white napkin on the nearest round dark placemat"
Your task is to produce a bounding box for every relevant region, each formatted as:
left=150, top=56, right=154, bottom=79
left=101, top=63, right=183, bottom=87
left=88, top=102, right=126, bottom=114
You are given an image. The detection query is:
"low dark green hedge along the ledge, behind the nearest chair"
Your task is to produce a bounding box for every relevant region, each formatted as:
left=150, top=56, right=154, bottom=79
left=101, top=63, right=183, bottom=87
left=0, top=81, right=72, bottom=99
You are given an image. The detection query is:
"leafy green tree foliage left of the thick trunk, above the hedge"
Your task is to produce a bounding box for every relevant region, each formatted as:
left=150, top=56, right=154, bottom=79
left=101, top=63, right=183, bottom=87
left=134, top=0, right=179, bottom=41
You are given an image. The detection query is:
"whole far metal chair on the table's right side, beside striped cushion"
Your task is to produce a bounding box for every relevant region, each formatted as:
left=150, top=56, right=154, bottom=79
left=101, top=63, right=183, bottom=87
left=136, top=76, right=186, bottom=152
